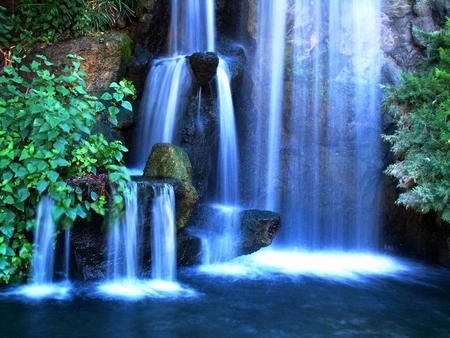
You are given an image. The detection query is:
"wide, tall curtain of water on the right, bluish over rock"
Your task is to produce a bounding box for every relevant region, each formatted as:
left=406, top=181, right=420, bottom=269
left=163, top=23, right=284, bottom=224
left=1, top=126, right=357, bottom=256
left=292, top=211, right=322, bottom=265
left=248, top=0, right=382, bottom=250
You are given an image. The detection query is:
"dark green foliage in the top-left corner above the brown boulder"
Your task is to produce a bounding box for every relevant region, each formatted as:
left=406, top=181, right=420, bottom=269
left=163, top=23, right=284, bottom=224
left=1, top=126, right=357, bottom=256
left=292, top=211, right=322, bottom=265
left=0, top=0, right=136, bottom=55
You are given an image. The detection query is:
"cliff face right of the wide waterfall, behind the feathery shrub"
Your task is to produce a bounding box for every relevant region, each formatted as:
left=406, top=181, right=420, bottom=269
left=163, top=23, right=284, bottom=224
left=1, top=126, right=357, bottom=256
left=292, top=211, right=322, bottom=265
left=382, top=0, right=450, bottom=267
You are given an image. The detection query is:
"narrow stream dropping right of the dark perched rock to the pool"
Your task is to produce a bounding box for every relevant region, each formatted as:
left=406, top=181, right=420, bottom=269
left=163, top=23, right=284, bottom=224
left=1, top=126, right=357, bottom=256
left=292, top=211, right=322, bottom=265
left=203, top=59, right=239, bottom=264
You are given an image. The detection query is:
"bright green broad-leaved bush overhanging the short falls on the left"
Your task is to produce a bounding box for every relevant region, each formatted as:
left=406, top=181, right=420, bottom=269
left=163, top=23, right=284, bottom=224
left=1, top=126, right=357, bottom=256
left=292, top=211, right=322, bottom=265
left=0, top=55, right=134, bottom=283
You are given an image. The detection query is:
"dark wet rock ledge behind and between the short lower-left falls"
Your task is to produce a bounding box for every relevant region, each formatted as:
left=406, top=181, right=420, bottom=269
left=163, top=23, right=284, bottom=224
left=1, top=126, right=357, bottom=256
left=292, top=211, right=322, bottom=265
left=71, top=177, right=201, bottom=281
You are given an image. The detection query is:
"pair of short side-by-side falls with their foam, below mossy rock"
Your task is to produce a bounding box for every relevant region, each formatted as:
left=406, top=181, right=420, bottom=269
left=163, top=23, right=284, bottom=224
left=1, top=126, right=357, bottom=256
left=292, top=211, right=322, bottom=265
left=98, top=182, right=194, bottom=299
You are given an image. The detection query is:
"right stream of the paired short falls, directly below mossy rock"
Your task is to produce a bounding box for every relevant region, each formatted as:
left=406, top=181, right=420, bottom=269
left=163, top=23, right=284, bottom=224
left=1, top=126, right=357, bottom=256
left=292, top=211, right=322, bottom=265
left=152, top=184, right=176, bottom=282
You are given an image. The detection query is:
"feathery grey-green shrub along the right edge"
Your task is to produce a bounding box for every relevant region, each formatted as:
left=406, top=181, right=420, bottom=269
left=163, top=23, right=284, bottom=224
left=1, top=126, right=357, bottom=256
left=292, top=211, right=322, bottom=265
left=384, top=20, right=450, bottom=222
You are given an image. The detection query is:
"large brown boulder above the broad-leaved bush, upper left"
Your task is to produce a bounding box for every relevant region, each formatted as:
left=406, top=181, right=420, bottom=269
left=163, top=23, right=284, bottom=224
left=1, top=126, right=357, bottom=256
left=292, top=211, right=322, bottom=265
left=32, top=31, right=133, bottom=96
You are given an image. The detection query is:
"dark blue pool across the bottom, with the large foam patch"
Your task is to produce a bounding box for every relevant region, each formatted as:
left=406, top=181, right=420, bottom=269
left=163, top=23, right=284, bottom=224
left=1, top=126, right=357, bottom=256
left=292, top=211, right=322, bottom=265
left=0, top=253, right=450, bottom=338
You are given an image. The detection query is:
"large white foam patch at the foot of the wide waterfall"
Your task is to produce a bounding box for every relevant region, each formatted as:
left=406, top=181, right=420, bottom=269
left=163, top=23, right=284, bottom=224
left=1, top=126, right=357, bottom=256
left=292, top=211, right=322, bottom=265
left=198, top=249, right=413, bottom=280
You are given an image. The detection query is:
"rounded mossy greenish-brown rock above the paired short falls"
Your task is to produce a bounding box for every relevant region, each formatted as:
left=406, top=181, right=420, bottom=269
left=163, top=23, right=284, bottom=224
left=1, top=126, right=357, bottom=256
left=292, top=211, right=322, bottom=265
left=144, top=143, right=198, bottom=229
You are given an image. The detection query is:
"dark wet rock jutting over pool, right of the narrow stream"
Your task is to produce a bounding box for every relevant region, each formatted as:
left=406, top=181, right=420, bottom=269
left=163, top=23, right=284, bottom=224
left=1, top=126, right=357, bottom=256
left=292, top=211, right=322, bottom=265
left=240, top=210, right=281, bottom=255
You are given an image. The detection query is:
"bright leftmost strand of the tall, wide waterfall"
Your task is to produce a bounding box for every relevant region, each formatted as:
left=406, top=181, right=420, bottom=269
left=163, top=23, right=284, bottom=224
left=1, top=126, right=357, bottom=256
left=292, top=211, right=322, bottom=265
left=250, top=0, right=287, bottom=210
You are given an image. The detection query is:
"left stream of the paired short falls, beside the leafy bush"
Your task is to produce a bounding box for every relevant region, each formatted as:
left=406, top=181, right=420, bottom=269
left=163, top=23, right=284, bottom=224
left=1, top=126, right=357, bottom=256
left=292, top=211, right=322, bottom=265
left=108, top=182, right=140, bottom=284
